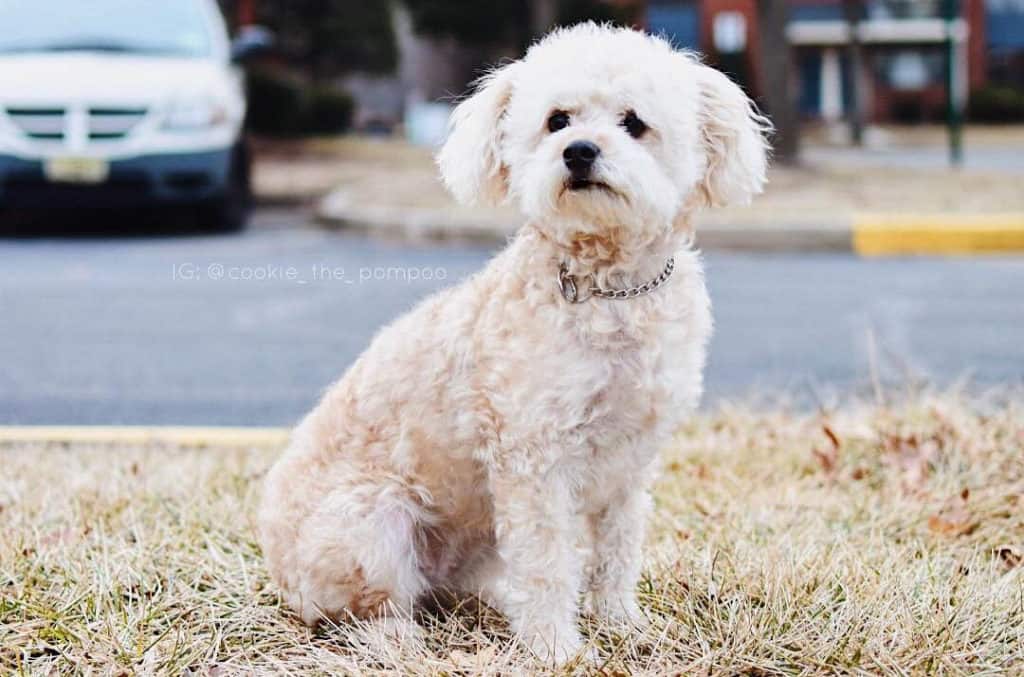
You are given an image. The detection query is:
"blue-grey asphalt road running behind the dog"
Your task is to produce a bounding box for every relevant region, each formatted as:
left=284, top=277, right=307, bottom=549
left=0, top=210, right=1024, bottom=425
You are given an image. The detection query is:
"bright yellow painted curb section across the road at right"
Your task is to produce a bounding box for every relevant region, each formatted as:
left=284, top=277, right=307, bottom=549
left=853, top=213, right=1024, bottom=256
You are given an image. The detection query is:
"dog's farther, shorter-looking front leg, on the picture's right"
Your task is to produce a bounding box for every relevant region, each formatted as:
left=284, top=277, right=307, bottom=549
left=587, top=488, right=650, bottom=627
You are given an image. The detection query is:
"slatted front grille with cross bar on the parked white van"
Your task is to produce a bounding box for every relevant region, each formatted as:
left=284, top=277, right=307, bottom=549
left=6, top=107, right=148, bottom=145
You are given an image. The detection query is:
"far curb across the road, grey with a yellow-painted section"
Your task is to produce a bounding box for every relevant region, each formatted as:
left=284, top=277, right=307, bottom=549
left=316, top=192, right=1024, bottom=256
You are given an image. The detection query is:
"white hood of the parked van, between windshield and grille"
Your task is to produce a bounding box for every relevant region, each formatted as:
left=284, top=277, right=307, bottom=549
left=0, top=52, right=234, bottom=104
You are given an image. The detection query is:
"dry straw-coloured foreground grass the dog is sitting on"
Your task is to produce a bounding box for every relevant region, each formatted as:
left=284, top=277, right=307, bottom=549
left=0, top=396, right=1024, bottom=675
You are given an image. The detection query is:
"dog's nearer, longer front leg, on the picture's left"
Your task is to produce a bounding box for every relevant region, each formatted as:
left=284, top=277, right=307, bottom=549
left=486, top=468, right=583, bottom=662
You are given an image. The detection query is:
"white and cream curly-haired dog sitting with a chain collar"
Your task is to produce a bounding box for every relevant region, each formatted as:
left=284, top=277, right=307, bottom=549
left=259, top=24, right=768, bottom=661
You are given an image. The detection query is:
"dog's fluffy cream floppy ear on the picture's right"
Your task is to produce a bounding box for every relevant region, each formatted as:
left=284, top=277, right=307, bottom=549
left=696, top=66, right=772, bottom=207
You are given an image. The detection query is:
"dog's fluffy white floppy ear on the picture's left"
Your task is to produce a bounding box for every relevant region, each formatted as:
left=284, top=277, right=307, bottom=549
left=437, top=62, right=519, bottom=205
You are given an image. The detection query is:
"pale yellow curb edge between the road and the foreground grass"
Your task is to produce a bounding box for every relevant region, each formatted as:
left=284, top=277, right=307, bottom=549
left=0, top=426, right=289, bottom=447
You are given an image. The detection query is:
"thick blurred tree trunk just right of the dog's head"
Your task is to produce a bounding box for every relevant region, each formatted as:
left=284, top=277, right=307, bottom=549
left=758, top=0, right=800, bottom=164
